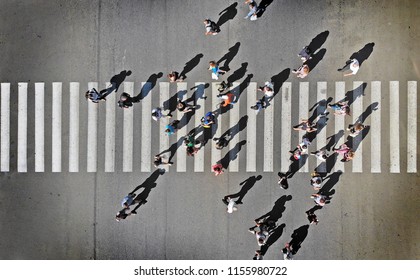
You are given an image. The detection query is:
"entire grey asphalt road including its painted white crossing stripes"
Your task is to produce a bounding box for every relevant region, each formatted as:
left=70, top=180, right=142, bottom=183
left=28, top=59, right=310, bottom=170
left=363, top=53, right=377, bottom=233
left=0, top=0, right=420, bottom=260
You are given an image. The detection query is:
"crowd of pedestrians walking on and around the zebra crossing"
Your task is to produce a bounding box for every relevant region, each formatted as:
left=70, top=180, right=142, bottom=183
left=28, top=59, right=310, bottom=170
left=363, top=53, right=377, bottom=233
left=81, top=0, right=366, bottom=260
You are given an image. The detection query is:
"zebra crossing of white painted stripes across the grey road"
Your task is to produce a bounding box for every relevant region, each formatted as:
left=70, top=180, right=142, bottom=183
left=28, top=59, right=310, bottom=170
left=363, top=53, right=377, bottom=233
left=0, top=81, right=418, bottom=173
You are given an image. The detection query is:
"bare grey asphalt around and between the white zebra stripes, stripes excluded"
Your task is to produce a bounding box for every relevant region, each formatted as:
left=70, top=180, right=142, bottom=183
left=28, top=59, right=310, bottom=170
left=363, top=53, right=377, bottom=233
left=0, top=0, right=420, bottom=259
